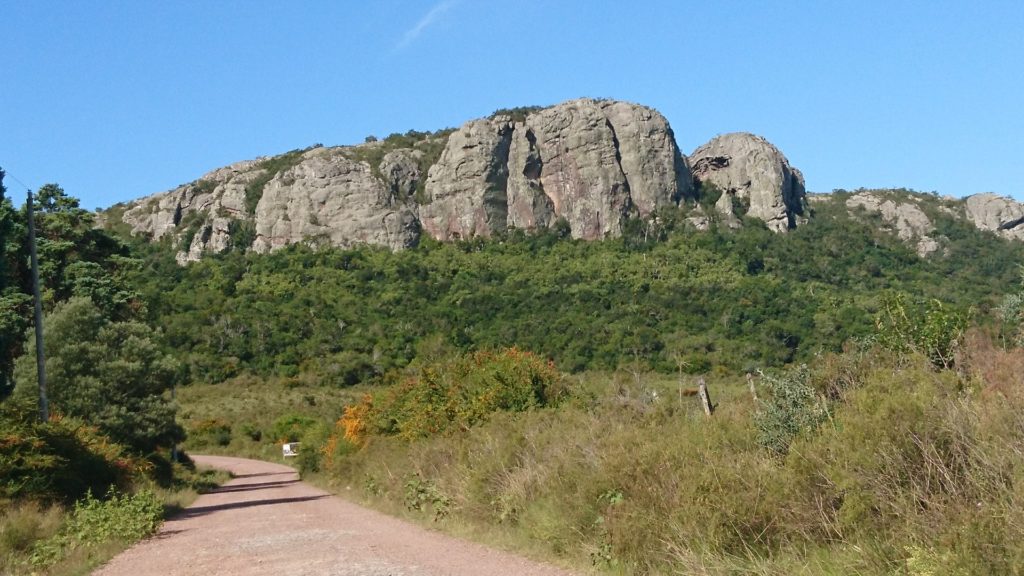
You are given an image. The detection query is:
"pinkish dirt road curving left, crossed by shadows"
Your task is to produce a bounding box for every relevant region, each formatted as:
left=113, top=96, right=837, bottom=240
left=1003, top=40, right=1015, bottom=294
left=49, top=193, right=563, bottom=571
left=94, top=456, right=569, bottom=576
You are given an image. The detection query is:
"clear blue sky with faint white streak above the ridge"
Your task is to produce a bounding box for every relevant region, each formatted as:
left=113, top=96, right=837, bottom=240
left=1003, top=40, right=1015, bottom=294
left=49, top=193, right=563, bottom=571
left=0, top=0, right=1024, bottom=208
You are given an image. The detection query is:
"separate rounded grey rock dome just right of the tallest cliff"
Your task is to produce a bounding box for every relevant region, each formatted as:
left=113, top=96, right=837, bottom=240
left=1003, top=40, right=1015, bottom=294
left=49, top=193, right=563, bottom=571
left=689, top=132, right=805, bottom=232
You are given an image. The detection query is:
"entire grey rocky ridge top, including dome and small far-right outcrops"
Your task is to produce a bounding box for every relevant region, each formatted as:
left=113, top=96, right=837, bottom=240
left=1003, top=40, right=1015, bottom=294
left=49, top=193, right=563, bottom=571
left=103, top=98, right=1024, bottom=263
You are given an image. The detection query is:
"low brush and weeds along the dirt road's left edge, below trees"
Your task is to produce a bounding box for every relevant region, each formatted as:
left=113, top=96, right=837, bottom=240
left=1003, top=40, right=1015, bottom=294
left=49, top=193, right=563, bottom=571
left=0, top=400, right=224, bottom=576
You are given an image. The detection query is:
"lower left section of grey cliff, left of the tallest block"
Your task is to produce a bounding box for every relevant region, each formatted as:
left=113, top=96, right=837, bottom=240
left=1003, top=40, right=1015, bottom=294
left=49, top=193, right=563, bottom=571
left=123, top=148, right=420, bottom=263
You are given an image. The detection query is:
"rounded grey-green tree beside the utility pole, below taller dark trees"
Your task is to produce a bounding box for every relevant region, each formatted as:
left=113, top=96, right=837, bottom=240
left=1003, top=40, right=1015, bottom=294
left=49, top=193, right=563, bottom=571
left=15, top=296, right=184, bottom=453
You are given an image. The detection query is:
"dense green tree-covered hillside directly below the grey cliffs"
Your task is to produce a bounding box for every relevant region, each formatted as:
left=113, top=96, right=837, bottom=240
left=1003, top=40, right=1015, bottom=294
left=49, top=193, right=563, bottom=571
left=116, top=192, right=1024, bottom=385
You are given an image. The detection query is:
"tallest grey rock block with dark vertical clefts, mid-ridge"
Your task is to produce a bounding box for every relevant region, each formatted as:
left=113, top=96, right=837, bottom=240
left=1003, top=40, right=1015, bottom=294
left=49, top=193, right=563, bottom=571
left=420, top=98, right=690, bottom=240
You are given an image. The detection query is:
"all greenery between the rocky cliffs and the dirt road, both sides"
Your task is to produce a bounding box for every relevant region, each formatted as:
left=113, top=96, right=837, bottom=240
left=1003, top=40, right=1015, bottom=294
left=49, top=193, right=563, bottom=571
left=0, top=165, right=1024, bottom=575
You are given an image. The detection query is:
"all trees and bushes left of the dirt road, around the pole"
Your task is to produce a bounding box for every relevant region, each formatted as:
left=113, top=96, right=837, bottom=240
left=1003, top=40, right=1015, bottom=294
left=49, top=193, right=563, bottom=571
left=0, top=171, right=223, bottom=576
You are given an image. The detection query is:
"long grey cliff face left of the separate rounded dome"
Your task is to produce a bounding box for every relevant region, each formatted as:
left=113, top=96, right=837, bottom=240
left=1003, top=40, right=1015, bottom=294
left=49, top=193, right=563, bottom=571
left=114, top=98, right=712, bottom=262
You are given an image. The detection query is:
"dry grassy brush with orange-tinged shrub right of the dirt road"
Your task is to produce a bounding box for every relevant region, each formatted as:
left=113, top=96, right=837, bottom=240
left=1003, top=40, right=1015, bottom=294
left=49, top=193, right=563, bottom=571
left=290, top=338, right=1024, bottom=575
